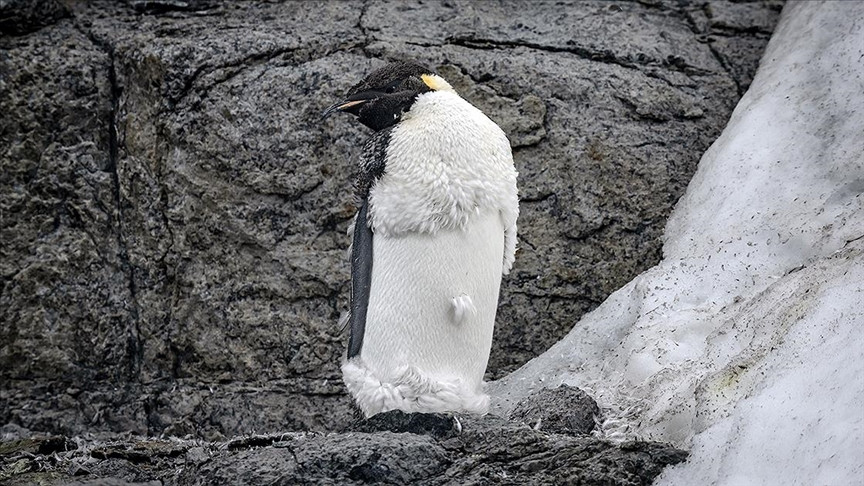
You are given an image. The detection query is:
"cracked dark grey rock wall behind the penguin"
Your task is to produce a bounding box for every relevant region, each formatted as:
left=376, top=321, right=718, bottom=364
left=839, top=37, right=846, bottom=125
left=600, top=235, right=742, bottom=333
left=0, top=1, right=779, bottom=440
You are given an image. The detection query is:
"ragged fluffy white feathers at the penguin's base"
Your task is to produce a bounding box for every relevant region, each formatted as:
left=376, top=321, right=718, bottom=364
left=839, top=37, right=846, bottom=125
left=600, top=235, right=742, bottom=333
left=342, top=357, right=489, bottom=417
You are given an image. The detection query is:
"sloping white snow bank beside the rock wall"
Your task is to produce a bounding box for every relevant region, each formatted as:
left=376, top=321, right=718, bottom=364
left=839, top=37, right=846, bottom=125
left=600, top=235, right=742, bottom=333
left=490, top=2, right=864, bottom=485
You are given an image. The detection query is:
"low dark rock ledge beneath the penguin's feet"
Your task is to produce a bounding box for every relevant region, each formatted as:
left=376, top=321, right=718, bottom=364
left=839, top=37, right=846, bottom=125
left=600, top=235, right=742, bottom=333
left=0, top=412, right=687, bottom=486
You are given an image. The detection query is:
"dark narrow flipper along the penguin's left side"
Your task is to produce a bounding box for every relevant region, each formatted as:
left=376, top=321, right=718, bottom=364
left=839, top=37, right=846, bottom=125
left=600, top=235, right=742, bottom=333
left=348, top=128, right=391, bottom=359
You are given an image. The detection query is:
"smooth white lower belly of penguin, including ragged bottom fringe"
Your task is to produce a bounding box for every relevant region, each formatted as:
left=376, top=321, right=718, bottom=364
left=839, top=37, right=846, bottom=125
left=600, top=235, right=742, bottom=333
left=343, top=210, right=505, bottom=416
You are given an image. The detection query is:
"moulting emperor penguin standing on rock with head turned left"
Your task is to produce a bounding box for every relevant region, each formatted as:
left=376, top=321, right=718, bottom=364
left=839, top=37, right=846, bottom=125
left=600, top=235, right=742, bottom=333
left=324, top=62, right=519, bottom=417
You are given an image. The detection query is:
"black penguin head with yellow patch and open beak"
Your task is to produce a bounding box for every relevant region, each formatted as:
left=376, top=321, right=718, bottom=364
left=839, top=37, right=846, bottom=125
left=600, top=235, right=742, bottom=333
left=322, top=61, right=453, bottom=132
